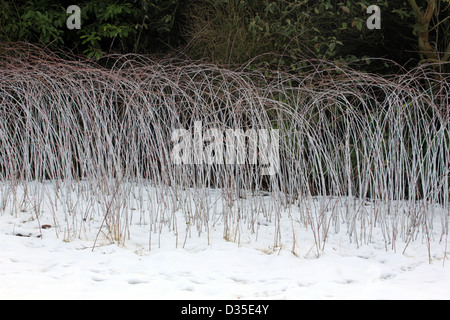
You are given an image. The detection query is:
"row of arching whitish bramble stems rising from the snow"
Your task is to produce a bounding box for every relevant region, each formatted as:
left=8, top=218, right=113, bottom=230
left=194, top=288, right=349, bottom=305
left=0, top=44, right=450, bottom=254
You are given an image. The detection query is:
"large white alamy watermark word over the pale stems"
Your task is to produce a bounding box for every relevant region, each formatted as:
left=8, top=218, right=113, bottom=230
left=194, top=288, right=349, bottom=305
left=171, top=121, right=280, bottom=176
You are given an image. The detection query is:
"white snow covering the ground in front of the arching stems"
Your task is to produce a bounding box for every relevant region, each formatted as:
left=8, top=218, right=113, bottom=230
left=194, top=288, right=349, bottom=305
left=0, top=184, right=450, bottom=300
